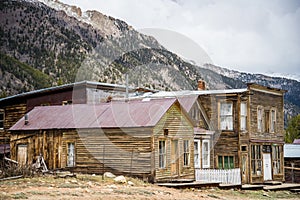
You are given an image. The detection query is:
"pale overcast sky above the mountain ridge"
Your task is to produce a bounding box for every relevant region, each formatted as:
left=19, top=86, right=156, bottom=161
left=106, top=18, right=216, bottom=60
left=61, top=0, right=300, bottom=75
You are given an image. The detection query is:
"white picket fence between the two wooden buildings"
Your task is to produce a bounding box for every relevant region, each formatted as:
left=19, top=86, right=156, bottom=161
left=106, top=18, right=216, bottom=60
left=195, top=168, right=241, bottom=185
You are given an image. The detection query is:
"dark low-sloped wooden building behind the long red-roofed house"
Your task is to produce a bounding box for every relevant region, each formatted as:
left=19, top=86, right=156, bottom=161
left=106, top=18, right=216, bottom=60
left=0, top=81, right=149, bottom=144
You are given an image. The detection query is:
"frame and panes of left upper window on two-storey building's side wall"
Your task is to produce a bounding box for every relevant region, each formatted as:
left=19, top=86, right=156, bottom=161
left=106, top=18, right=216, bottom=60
left=219, top=101, right=234, bottom=131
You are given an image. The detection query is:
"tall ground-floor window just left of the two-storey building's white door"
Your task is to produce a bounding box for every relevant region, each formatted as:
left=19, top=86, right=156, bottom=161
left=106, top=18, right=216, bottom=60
left=251, top=145, right=262, bottom=176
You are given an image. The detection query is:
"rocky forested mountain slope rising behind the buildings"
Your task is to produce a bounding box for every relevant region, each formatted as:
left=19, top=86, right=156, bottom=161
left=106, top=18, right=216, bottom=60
left=0, top=0, right=300, bottom=120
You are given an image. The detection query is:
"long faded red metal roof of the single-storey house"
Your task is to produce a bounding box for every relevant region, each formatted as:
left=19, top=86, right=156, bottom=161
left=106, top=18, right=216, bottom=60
left=10, top=98, right=176, bottom=131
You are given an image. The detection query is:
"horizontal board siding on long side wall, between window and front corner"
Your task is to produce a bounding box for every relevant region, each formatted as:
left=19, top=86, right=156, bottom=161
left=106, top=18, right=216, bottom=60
left=76, top=128, right=152, bottom=177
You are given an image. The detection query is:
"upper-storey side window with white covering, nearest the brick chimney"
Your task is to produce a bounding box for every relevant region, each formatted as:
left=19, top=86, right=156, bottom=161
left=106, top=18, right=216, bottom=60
left=220, top=102, right=233, bottom=130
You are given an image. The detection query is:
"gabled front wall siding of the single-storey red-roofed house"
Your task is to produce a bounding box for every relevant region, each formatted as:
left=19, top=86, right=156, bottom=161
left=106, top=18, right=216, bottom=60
left=152, top=104, right=195, bottom=181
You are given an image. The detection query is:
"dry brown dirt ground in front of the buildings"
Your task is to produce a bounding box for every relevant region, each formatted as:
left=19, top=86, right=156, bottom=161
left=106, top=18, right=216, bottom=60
left=0, top=174, right=300, bottom=200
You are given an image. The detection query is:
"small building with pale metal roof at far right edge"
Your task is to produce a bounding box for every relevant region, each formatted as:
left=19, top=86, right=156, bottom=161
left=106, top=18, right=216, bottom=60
left=284, top=143, right=300, bottom=183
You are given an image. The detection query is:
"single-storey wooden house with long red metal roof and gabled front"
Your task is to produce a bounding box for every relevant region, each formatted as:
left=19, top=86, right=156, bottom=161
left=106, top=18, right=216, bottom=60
left=9, top=98, right=194, bottom=182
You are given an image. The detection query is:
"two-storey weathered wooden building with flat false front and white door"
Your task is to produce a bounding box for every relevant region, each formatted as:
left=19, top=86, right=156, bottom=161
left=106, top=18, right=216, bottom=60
left=152, top=81, right=285, bottom=183
